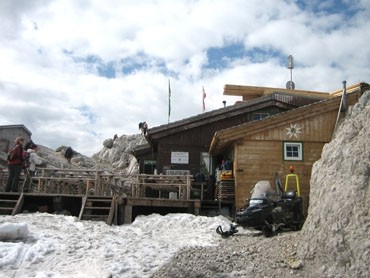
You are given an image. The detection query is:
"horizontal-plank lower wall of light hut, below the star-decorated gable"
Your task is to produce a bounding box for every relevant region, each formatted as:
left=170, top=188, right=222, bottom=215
left=234, top=140, right=324, bottom=209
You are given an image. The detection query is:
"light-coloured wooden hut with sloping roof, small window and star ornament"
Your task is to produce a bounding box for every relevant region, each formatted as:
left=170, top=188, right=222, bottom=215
left=209, top=83, right=369, bottom=210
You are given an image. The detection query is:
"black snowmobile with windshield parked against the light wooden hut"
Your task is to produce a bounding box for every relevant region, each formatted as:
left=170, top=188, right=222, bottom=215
left=235, top=181, right=304, bottom=237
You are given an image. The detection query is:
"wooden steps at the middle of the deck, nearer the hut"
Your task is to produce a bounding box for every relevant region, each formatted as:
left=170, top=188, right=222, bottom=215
left=79, top=196, right=117, bottom=225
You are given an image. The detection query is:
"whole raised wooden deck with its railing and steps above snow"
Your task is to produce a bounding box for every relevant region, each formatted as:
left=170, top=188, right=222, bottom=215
left=0, top=168, right=220, bottom=225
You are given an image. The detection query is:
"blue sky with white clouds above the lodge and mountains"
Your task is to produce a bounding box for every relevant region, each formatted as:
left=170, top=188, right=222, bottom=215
left=0, top=0, right=370, bottom=156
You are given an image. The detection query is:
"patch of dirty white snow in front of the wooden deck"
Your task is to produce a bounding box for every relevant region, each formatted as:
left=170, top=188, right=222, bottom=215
left=0, top=213, right=230, bottom=278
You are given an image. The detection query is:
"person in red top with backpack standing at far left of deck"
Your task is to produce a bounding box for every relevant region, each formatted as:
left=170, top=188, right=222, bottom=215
left=5, top=137, right=24, bottom=192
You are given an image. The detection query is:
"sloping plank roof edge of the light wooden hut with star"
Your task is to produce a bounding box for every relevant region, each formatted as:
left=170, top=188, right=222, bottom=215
left=209, top=87, right=368, bottom=154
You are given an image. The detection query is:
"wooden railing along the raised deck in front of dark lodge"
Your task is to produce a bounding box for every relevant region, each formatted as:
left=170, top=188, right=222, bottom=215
left=2, top=168, right=203, bottom=200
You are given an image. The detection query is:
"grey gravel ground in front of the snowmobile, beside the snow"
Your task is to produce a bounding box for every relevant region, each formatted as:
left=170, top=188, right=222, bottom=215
left=153, top=228, right=310, bottom=278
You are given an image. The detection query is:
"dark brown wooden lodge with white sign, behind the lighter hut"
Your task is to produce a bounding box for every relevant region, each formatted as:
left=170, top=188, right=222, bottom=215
left=133, top=85, right=327, bottom=210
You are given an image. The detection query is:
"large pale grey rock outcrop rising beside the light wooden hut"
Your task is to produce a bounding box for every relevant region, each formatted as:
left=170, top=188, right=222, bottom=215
left=299, top=91, right=370, bottom=277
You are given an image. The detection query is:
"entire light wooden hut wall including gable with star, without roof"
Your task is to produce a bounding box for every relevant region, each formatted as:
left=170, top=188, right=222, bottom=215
left=234, top=108, right=337, bottom=211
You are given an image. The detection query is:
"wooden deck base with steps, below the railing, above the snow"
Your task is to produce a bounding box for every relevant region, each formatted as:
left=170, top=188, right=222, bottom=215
left=0, top=192, right=201, bottom=225
